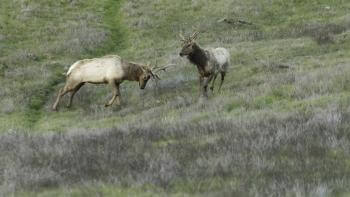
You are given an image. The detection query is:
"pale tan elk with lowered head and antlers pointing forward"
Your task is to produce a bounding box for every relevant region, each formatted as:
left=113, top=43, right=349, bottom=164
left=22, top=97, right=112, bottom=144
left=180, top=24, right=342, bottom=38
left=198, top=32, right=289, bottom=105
left=52, top=55, right=165, bottom=111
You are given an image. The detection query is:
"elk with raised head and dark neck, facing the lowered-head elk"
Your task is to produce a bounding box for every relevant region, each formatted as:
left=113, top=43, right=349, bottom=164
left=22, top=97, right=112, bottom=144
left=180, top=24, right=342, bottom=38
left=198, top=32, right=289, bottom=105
left=180, top=32, right=230, bottom=98
